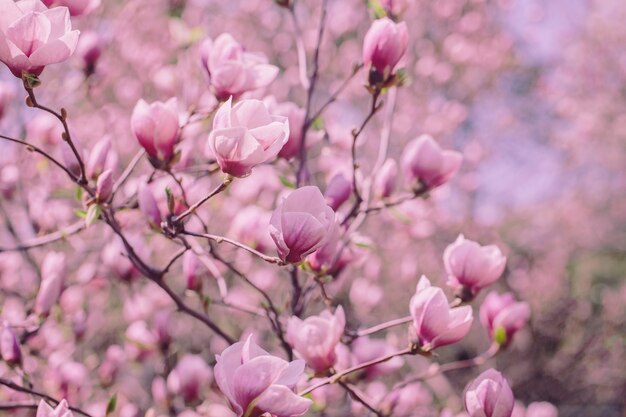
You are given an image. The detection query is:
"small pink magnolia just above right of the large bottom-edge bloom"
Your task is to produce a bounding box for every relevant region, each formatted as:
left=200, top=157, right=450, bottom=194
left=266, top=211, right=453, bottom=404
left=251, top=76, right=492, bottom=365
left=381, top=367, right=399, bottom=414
left=287, top=306, right=346, bottom=373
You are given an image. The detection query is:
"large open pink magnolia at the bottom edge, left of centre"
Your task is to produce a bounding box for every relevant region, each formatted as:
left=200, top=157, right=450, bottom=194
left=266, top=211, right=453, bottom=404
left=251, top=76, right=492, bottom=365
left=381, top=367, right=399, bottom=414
left=214, top=336, right=312, bottom=417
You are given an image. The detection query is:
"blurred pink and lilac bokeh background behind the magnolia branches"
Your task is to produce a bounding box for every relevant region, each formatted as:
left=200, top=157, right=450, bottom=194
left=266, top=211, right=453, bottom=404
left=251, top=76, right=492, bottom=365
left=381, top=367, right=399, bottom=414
left=0, top=0, right=626, bottom=417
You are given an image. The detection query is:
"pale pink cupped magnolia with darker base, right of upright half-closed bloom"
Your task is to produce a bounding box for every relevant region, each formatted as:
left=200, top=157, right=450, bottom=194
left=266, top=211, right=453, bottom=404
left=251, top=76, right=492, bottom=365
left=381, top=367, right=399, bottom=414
left=208, top=98, right=289, bottom=177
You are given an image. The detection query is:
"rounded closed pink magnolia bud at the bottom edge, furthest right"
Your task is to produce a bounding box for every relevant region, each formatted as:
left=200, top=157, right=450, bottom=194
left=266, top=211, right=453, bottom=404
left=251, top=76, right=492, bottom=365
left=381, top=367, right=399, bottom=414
left=464, top=369, right=515, bottom=417
